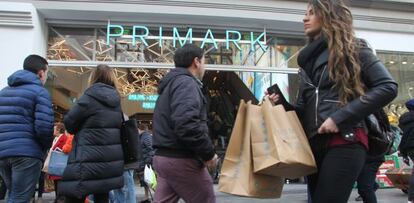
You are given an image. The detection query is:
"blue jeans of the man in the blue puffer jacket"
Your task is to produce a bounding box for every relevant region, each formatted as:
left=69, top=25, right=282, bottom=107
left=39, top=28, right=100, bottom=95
left=0, top=157, right=42, bottom=203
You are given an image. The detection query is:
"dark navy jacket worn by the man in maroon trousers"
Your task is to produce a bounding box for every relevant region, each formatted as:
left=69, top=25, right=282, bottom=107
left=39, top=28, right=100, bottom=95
left=153, top=68, right=215, bottom=161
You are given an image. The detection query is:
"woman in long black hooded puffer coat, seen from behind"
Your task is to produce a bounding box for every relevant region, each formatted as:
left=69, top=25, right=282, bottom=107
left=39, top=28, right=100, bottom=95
left=58, top=65, right=124, bottom=203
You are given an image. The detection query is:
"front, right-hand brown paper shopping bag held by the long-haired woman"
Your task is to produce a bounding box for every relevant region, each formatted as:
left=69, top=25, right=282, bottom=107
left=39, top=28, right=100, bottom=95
left=251, top=99, right=317, bottom=178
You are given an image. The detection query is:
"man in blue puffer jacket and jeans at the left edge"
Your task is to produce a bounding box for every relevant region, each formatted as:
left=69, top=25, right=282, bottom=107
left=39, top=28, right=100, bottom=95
left=0, top=55, right=54, bottom=203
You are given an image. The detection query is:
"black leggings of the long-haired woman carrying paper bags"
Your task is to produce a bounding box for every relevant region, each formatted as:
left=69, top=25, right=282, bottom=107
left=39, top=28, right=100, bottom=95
left=308, top=144, right=366, bottom=203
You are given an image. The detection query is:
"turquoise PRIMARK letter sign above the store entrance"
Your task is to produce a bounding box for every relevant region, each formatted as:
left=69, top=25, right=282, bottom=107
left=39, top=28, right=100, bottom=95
left=106, top=22, right=267, bottom=51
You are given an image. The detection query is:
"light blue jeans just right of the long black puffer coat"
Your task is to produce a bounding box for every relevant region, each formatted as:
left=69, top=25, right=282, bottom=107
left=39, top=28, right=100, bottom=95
left=113, top=170, right=137, bottom=203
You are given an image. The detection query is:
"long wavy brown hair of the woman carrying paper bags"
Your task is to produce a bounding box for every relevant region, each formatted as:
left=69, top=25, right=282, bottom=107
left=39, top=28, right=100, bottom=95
left=309, top=0, right=364, bottom=105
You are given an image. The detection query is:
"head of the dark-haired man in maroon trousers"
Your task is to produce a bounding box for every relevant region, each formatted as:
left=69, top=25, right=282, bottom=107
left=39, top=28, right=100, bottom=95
left=174, top=44, right=205, bottom=80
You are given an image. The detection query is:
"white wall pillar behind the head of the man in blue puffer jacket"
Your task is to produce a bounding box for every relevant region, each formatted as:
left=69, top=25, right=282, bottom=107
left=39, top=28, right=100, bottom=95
left=0, top=2, right=47, bottom=88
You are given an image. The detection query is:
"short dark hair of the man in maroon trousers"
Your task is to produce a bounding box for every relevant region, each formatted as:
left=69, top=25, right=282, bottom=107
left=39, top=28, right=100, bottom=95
left=174, top=44, right=204, bottom=68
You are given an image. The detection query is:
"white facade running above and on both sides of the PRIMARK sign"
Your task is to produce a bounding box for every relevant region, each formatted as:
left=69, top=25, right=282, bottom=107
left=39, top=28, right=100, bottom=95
left=0, top=0, right=414, bottom=87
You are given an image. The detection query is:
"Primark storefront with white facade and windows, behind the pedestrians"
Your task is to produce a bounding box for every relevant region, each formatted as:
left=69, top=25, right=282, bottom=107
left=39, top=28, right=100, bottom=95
left=0, top=0, right=414, bottom=132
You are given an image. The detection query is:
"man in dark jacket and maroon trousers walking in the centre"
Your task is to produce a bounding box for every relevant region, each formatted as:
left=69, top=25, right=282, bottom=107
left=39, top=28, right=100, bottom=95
left=153, top=44, right=217, bottom=203
